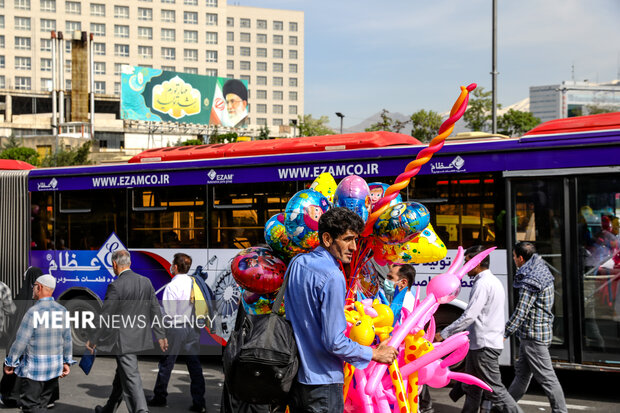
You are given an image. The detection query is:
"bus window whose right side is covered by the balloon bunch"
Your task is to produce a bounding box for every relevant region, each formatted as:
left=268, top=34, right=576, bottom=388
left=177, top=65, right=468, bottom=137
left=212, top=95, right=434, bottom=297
left=209, top=182, right=297, bottom=248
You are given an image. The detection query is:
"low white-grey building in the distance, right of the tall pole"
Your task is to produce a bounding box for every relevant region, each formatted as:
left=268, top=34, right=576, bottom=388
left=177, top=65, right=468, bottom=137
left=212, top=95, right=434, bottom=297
left=530, top=80, right=620, bottom=122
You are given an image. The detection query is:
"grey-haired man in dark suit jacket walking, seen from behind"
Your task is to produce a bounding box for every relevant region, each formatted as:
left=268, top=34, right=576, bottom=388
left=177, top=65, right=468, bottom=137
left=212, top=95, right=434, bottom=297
left=86, top=250, right=168, bottom=413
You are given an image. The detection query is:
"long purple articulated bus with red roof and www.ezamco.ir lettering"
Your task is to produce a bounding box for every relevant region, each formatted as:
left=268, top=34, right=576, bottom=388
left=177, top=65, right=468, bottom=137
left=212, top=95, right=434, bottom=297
left=0, top=113, right=620, bottom=369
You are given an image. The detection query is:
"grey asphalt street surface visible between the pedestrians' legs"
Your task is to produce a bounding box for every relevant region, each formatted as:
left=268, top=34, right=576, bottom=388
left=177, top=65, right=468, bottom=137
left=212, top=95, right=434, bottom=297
left=0, top=356, right=620, bottom=413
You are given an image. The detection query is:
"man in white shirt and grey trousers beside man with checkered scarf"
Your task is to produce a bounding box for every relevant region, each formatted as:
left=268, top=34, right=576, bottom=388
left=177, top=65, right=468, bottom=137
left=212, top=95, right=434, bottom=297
left=435, top=245, right=523, bottom=413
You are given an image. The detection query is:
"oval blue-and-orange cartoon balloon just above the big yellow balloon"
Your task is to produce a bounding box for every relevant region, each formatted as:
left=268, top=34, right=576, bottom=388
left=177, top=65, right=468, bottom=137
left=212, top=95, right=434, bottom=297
left=373, top=202, right=431, bottom=244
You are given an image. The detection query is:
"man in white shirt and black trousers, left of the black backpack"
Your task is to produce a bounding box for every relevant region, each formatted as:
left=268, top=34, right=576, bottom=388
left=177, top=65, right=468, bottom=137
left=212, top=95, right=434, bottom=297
left=148, top=253, right=206, bottom=412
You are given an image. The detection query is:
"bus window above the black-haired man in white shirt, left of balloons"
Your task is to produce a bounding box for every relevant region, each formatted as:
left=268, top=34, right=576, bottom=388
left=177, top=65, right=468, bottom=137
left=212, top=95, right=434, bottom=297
left=129, top=185, right=207, bottom=248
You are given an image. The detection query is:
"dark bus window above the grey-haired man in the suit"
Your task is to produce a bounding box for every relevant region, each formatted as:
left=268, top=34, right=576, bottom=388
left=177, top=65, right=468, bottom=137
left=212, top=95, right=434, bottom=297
left=54, top=190, right=126, bottom=250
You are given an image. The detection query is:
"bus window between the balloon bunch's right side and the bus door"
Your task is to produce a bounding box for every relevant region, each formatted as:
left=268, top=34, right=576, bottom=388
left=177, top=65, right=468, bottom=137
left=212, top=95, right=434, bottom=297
left=408, top=174, right=505, bottom=249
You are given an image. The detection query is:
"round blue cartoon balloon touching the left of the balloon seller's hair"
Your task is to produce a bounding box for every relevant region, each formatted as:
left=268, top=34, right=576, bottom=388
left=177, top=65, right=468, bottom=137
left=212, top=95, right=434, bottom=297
left=284, top=189, right=329, bottom=249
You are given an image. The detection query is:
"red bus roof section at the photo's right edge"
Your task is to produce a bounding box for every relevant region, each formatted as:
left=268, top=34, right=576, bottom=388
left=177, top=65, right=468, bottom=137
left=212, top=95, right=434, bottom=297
left=524, top=112, right=620, bottom=136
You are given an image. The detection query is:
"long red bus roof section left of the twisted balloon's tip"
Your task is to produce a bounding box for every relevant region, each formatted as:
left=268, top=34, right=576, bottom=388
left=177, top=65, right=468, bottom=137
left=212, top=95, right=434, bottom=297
left=129, top=131, right=421, bottom=163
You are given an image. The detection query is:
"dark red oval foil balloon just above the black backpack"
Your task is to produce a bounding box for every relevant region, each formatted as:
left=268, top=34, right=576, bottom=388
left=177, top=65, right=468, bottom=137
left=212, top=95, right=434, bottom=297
left=231, top=247, right=286, bottom=294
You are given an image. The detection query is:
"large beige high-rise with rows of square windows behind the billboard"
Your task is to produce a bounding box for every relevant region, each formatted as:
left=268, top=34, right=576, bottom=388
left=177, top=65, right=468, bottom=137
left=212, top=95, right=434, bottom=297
left=0, top=0, right=304, bottom=146
